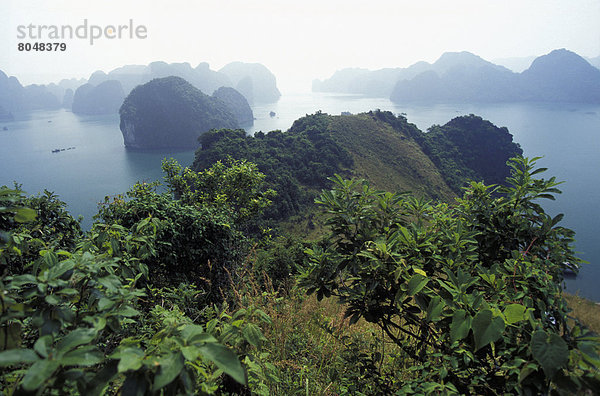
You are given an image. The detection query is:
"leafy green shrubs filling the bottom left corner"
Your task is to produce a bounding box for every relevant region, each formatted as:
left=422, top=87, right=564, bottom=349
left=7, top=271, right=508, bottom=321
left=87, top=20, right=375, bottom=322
left=0, top=213, right=246, bottom=395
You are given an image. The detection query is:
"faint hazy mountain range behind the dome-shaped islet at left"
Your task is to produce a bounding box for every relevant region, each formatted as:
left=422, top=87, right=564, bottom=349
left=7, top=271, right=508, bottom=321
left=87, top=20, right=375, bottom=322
left=0, top=62, right=281, bottom=119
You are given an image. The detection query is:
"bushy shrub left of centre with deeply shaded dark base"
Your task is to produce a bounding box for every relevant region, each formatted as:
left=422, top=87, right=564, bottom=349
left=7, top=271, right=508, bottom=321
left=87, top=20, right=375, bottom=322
left=97, top=160, right=273, bottom=302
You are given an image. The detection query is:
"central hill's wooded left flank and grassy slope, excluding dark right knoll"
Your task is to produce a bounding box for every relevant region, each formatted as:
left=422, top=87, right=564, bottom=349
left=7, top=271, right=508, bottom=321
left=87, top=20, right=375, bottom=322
left=192, top=111, right=458, bottom=226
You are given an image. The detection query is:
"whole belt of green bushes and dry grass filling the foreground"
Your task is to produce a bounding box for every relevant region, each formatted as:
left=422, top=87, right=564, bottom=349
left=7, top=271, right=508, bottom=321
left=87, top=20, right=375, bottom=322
left=0, top=158, right=600, bottom=395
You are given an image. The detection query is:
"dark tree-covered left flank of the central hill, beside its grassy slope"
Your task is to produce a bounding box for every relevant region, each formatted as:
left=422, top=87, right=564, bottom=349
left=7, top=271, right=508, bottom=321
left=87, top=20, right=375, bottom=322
left=192, top=113, right=352, bottom=220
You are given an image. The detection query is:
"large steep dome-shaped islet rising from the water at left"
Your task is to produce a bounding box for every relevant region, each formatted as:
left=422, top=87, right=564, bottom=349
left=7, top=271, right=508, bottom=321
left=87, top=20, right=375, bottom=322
left=119, top=76, right=239, bottom=150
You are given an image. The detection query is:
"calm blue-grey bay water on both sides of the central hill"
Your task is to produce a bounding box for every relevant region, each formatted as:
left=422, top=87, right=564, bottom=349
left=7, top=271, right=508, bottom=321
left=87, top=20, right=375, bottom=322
left=0, top=94, right=600, bottom=301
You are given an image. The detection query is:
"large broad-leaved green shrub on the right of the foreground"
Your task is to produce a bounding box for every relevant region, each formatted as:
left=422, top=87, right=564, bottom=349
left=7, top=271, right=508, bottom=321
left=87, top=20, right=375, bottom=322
left=301, top=157, right=600, bottom=394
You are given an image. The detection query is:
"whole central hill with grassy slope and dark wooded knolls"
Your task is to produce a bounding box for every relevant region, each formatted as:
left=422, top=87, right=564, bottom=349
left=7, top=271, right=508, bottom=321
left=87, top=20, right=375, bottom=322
left=192, top=110, right=522, bottom=226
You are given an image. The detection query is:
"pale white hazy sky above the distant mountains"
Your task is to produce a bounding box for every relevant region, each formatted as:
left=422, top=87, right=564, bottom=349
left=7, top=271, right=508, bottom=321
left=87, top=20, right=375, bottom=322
left=0, top=0, right=600, bottom=92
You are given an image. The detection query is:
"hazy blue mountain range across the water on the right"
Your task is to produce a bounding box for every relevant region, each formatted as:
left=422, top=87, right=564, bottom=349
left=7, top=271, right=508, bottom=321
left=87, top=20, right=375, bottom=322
left=313, top=49, right=600, bottom=103
